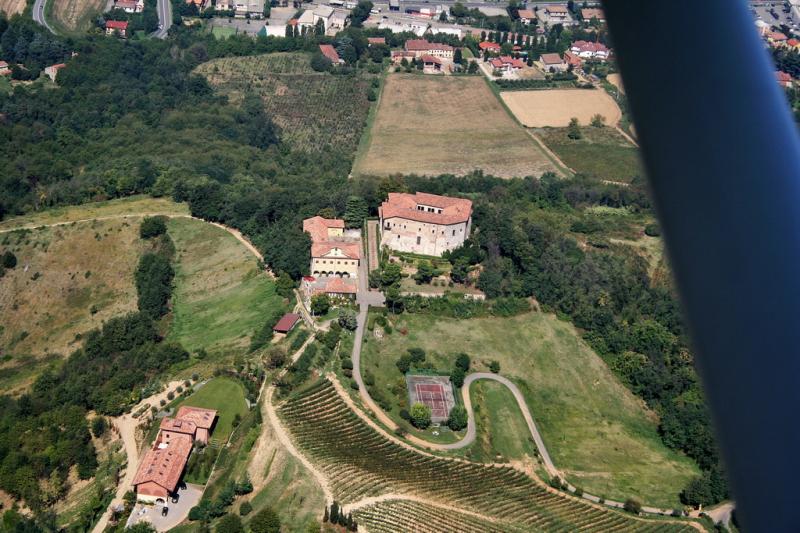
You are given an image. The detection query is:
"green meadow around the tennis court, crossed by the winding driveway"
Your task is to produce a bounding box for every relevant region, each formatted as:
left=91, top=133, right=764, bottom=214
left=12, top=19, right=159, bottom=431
left=363, top=313, right=698, bottom=507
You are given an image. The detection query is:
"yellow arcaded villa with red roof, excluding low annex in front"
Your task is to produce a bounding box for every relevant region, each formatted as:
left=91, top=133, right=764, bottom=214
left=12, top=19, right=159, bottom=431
left=303, top=216, right=361, bottom=290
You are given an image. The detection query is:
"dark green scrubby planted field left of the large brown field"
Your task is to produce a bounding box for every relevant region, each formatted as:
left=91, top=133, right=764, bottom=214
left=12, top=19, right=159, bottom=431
left=196, top=53, right=370, bottom=152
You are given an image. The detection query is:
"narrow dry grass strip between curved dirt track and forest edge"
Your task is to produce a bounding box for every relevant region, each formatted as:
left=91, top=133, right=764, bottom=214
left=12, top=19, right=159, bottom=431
left=0, top=196, right=189, bottom=231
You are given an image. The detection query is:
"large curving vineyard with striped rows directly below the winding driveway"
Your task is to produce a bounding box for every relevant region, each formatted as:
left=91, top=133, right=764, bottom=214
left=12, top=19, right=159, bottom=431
left=280, top=381, right=689, bottom=531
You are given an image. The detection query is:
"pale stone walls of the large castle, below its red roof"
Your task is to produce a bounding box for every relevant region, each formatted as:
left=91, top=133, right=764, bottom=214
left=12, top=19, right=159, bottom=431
left=381, top=218, right=472, bottom=256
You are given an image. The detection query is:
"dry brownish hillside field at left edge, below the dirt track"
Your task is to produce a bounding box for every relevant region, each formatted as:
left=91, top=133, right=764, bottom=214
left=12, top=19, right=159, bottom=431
left=0, top=218, right=142, bottom=392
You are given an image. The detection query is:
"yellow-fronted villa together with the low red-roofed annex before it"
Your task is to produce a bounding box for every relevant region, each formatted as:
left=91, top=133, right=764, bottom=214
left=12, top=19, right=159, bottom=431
left=303, top=216, right=361, bottom=297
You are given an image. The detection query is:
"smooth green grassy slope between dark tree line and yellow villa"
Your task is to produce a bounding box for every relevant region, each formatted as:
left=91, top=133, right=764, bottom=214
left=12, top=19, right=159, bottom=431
left=167, top=218, right=284, bottom=355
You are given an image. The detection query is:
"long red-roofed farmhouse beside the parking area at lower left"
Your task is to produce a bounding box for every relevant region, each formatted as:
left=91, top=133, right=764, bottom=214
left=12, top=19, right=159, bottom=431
left=133, top=406, right=217, bottom=503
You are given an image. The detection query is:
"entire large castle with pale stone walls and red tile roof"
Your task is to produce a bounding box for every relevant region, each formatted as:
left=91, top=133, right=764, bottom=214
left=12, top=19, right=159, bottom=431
left=379, top=192, right=472, bottom=256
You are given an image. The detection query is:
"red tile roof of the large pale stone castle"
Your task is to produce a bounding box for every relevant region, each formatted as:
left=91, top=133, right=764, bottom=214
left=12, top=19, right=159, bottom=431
left=380, top=192, right=472, bottom=225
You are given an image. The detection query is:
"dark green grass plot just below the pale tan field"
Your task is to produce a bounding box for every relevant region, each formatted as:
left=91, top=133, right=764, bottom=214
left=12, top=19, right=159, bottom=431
left=536, top=127, right=644, bottom=183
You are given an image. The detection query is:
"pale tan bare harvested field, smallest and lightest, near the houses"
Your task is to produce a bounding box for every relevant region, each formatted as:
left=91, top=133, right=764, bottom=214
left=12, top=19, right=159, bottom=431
left=500, top=89, right=622, bottom=128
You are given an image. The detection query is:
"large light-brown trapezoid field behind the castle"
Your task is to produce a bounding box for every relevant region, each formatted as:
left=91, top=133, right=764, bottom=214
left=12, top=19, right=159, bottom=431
left=353, top=73, right=559, bottom=178
